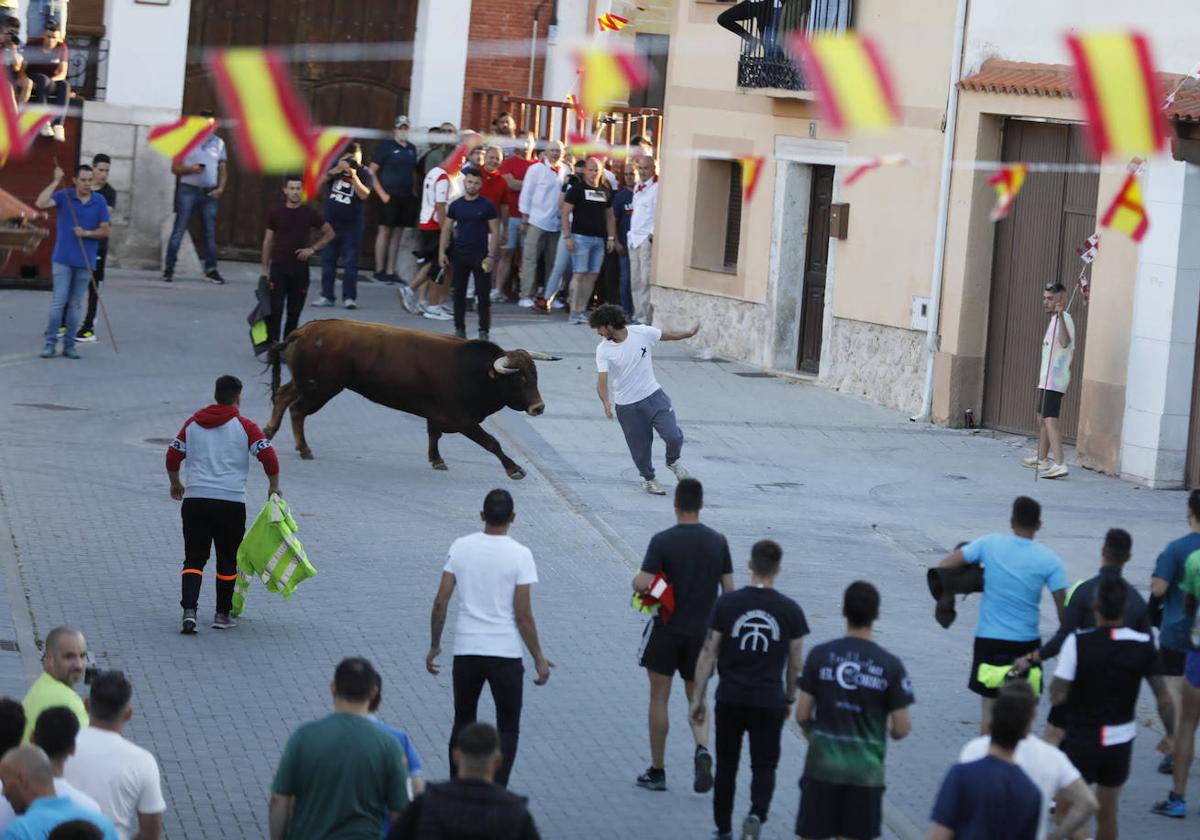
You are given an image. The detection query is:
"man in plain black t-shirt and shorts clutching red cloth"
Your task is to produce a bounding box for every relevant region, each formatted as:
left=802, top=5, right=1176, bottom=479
left=634, top=479, right=733, bottom=793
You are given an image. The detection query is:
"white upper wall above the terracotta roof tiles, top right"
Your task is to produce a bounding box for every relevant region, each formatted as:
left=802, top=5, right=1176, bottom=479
left=964, top=0, right=1200, bottom=74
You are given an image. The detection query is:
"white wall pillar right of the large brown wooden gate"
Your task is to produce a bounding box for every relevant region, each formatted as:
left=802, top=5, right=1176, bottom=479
left=408, top=0, right=470, bottom=130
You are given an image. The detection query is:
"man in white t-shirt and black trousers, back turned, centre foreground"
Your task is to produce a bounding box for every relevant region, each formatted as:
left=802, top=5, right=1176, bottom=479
left=425, top=490, right=554, bottom=787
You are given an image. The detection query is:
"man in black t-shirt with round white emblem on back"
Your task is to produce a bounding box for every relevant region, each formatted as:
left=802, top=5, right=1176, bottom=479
left=690, top=540, right=809, bottom=839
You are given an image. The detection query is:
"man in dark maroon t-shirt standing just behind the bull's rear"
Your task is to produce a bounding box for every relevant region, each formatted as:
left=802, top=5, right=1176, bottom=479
left=263, top=175, right=334, bottom=341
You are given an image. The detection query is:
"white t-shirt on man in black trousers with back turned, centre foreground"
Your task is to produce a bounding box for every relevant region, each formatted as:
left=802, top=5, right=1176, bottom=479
left=443, top=532, right=538, bottom=659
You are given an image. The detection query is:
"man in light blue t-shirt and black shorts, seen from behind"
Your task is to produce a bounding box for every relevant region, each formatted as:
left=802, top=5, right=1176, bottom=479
left=941, top=496, right=1068, bottom=734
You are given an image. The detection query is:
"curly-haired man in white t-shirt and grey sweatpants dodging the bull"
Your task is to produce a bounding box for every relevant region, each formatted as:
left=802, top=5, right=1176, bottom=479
left=588, top=304, right=700, bottom=496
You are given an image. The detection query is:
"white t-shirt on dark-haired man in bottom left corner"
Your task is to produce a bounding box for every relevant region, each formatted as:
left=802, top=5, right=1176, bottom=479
left=62, top=726, right=167, bottom=840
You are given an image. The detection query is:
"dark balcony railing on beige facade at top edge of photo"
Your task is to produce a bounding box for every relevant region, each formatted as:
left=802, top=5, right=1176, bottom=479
left=731, top=0, right=854, bottom=90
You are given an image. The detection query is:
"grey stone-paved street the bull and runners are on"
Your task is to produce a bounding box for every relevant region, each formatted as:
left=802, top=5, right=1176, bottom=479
left=0, top=266, right=1200, bottom=840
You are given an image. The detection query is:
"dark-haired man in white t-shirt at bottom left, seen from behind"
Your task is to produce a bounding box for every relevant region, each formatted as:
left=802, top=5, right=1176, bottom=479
left=64, top=671, right=167, bottom=840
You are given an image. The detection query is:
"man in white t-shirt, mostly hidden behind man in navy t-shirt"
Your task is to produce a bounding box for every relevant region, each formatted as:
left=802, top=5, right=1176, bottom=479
left=959, top=679, right=1099, bottom=840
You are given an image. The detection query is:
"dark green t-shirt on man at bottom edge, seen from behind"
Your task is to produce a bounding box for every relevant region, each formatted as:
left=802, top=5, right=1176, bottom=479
left=271, top=712, right=409, bottom=840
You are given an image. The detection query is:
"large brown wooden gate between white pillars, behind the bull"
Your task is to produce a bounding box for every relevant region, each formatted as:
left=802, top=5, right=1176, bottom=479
left=184, top=0, right=416, bottom=266
